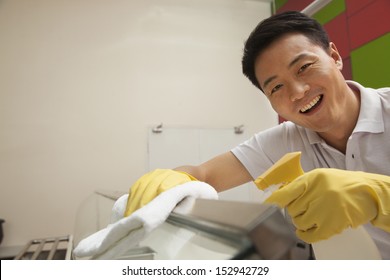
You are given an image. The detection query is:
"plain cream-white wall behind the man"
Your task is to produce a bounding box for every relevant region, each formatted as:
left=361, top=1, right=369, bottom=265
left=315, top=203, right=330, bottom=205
left=0, top=0, right=277, bottom=246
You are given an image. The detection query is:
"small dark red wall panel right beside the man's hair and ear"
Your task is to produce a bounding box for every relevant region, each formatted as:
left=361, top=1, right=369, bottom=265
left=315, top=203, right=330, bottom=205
left=324, top=12, right=350, bottom=58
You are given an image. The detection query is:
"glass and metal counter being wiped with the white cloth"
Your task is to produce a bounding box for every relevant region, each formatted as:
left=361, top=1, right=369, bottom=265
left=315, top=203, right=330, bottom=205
left=74, top=191, right=304, bottom=259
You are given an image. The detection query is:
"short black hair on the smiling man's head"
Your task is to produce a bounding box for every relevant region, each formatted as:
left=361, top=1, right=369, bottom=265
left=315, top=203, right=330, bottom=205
left=242, top=11, right=329, bottom=90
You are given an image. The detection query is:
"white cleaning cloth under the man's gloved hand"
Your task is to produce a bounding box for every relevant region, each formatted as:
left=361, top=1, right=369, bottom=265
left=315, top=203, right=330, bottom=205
left=73, top=181, right=218, bottom=259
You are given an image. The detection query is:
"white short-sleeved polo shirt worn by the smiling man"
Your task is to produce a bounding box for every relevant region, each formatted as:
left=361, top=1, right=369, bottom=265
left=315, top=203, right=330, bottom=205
left=232, top=81, right=390, bottom=259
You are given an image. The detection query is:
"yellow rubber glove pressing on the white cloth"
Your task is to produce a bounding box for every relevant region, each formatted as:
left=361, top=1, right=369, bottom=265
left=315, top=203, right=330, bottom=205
left=124, top=169, right=197, bottom=217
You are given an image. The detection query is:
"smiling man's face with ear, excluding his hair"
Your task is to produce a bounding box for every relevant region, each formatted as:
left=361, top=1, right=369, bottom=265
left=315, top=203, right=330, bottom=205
left=255, top=33, right=348, bottom=132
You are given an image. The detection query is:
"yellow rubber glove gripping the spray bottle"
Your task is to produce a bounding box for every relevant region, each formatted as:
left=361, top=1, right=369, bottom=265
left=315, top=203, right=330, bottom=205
left=266, top=168, right=390, bottom=243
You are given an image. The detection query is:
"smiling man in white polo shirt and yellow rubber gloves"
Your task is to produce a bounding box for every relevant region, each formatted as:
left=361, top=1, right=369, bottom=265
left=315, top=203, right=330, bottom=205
left=126, top=12, right=390, bottom=259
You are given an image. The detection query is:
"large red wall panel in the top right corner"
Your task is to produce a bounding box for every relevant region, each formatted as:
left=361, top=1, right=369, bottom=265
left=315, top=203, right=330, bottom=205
left=348, top=0, right=390, bottom=50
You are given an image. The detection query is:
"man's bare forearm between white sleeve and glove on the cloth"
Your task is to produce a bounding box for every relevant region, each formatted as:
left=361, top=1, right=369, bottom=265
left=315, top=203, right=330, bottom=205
left=174, top=152, right=253, bottom=192
